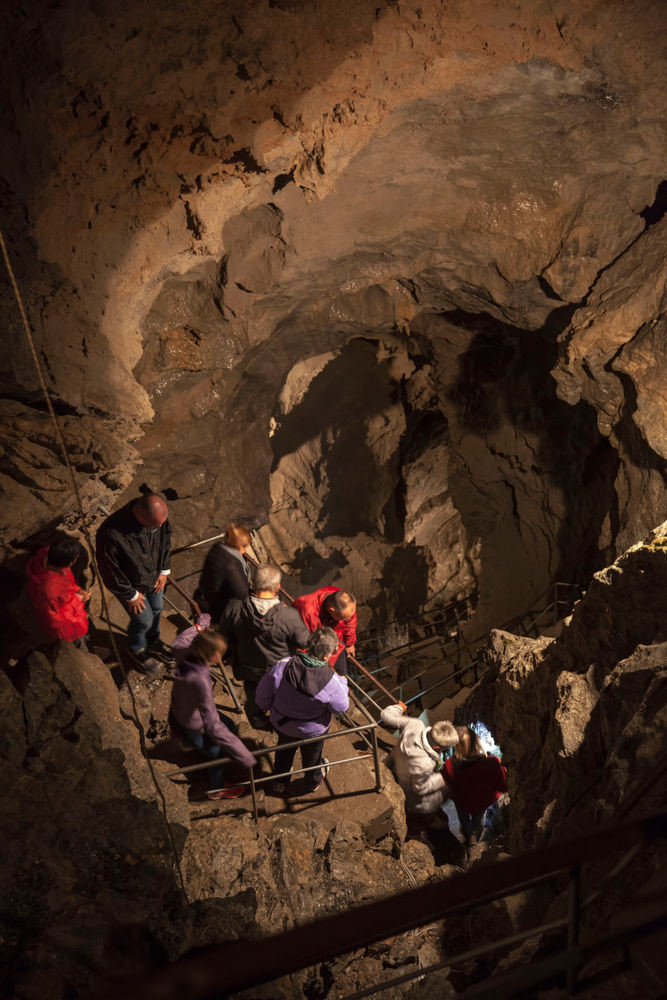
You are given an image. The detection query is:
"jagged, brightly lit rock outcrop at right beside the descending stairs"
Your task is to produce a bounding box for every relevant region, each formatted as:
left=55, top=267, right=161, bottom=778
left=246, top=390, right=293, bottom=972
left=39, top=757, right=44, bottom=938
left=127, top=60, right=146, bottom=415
left=468, top=522, right=667, bottom=848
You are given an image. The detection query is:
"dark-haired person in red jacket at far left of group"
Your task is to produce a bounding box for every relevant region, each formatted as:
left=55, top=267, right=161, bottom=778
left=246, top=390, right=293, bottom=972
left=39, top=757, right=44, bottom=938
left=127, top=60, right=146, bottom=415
left=26, top=535, right=90, bottom=645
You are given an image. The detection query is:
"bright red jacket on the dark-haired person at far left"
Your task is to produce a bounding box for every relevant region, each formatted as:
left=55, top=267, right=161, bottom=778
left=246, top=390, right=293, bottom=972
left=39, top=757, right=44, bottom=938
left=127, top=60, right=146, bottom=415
left=26, top=545, right=88, bottom=642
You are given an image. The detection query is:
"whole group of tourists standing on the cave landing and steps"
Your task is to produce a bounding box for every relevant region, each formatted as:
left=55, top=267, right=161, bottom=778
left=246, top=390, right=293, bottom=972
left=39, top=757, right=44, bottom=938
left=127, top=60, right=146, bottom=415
left=27, top=494, right=506, bottom=843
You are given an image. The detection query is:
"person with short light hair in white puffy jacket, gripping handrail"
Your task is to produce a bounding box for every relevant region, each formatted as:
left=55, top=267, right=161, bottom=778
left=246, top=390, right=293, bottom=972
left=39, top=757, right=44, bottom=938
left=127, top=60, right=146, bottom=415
left=381, top=702, right=459, bottom=822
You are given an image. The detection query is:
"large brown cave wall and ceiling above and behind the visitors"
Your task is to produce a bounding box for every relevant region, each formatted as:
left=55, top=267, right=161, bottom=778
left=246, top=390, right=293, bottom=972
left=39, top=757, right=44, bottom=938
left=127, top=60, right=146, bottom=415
left=0, top=0, right=667, bottom=623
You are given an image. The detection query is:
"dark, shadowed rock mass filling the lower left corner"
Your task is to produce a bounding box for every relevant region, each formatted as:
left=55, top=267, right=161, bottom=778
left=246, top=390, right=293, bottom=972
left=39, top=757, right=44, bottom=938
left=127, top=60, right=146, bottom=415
left=0, top=646, right=190, bottom=998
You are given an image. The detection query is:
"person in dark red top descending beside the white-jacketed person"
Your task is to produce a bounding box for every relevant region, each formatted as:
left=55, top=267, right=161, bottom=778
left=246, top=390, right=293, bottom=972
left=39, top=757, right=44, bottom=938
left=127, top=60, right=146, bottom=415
left=445, top=726, right=507, bottom=846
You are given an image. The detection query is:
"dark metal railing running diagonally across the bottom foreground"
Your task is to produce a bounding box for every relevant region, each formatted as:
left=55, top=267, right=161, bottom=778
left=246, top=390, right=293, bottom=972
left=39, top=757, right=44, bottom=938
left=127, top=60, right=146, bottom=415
left=109, top=812, right=667, bottom=1000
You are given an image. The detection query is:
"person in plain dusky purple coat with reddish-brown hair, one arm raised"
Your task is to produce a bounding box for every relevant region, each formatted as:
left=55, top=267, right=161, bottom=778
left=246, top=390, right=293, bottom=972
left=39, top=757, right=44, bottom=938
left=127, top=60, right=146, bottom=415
left=169, top=615, right=257, bottom=799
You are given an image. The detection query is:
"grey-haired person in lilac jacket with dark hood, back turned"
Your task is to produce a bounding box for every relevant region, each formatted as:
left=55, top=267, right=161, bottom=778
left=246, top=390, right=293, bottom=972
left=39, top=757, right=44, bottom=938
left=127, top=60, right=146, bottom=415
left=255, top=628, right=350, bottom=795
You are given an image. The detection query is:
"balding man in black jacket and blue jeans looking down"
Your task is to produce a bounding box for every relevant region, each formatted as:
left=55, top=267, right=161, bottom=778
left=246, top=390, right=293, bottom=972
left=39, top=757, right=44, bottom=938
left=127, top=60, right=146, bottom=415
left=96, top=493, right=172, bottom=673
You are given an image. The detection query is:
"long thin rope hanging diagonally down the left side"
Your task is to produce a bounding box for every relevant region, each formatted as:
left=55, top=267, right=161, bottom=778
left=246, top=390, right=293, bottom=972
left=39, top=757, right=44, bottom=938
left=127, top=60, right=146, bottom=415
left=0, top=230, right=189, bottom=905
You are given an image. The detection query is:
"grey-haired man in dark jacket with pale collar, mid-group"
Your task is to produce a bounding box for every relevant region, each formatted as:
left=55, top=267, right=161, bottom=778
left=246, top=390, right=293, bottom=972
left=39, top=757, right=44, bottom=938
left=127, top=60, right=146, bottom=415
left=220, top=563, right=310, bottom=729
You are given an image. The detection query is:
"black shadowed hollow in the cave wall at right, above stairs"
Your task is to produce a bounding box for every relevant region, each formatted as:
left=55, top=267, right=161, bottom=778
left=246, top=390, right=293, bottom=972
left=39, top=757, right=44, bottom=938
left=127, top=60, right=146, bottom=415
left=447, top=306, right=619, bottom=584
